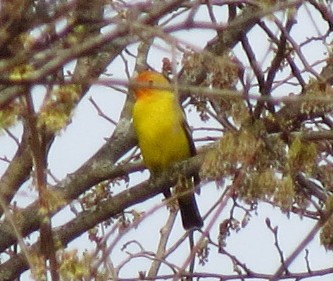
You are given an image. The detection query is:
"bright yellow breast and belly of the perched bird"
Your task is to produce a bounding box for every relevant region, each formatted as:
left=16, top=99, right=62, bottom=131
left=133, top=94, right=191, bottom=172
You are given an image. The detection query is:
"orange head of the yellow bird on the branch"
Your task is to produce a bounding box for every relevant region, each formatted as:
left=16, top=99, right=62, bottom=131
left=134, top=70, right=170, bottom=98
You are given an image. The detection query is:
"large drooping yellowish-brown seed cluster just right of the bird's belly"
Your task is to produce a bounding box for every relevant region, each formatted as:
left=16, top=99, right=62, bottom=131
left=201, top=121, right=302, bottom=209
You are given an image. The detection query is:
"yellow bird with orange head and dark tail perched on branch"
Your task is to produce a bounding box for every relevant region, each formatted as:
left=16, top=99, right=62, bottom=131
left=133, top=71, right=203, bottom=229
